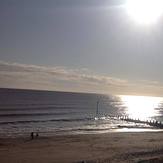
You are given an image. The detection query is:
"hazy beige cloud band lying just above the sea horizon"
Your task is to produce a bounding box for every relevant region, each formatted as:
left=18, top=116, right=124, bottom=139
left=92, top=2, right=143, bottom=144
left=0, top=61, right=163, bottom=95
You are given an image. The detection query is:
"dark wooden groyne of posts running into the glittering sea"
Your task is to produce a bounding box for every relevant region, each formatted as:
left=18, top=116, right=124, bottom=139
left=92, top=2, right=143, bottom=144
left=117, top=116, right=163, bottom=129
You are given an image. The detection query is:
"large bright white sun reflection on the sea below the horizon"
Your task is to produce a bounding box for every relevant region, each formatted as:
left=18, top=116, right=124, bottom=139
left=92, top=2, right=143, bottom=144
left=120, top=95, right=163, bottom=120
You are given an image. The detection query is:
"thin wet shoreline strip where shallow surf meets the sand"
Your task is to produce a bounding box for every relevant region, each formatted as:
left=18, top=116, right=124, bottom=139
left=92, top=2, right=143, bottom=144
left=0, top=127, right=163, bottom=139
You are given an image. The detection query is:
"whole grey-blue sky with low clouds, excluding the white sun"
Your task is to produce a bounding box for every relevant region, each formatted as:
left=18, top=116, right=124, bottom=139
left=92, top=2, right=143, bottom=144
left=0, top=0, right=163, bottom=96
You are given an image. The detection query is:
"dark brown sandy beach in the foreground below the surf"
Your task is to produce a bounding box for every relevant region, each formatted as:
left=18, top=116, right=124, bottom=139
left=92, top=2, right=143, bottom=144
left=0, top=132, right=163, bottom=163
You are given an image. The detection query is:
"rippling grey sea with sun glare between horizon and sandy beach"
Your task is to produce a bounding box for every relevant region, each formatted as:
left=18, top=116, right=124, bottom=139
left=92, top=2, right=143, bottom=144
left=0, top=89, right=163, bottom=137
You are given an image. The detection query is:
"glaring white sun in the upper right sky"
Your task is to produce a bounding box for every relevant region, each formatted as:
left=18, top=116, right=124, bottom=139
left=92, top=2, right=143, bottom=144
left=125, top=0, right=163, bottom=25
